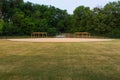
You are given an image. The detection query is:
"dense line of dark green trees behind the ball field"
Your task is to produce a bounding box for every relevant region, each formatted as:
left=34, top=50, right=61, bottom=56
left=0, top=0, right=120, bottom=38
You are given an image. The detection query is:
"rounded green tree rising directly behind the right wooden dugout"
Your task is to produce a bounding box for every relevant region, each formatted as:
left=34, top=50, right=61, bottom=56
left=74, top=6, right=92, bottom=31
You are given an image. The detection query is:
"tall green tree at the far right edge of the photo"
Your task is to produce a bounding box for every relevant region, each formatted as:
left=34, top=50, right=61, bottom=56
left=103, top=1, right=120, bottom=37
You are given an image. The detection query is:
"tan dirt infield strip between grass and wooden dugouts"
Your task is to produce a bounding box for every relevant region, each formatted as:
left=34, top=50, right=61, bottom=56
left=8, top=38, right=112, bottom=42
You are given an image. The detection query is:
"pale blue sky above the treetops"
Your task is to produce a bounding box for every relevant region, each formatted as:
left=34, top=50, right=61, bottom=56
left=24, top=0, right=118, bottom=14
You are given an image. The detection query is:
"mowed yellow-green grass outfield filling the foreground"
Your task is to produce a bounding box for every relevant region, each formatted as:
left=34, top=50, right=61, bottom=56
left=0, top=40, right=120, bottom=80
